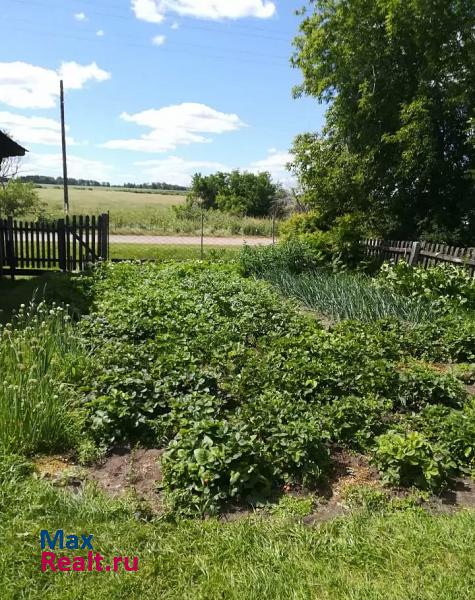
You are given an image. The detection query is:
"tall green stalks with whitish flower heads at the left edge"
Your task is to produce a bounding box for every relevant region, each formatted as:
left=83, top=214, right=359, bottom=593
left=0, top=303, right=80, bottom=453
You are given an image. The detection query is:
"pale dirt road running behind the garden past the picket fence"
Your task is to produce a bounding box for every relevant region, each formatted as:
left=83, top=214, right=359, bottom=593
left=109, top=235, right=272, bottom=246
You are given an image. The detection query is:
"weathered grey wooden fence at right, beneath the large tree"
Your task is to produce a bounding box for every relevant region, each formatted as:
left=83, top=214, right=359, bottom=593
left=363, top=240, right=475, bottom=276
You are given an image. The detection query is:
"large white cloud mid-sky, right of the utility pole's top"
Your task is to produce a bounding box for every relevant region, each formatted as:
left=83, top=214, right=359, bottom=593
left=103, top=102, right=245, bottom=152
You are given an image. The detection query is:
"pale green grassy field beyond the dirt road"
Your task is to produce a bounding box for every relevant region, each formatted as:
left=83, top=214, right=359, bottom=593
left=34, top=186, right=272, bottom=237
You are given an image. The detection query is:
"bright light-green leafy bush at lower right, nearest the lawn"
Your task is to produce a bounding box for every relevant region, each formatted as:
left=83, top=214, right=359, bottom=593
left=373, top=431, right=456, bottom=490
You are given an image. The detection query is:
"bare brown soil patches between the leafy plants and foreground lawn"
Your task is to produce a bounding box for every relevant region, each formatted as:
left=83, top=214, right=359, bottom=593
left=35, top=448, right=475, bottom=525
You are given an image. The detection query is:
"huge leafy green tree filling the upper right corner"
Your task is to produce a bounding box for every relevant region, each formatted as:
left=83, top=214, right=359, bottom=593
left=292, top=0, right=475, bottom=243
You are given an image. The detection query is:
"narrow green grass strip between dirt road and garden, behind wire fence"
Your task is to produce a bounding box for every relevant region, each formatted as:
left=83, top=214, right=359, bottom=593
left=110, top=244, right=240, bottom=261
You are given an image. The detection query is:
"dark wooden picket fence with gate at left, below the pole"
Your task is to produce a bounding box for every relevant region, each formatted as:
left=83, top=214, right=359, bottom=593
left=0, top=214, right=109, bottom=277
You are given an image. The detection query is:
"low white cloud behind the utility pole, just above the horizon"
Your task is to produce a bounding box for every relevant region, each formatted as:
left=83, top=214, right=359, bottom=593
left=21, top=152, right=114, bottom=181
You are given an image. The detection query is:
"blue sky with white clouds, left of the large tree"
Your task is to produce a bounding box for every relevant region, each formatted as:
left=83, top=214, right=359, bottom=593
left=0, top=0, right=324, bottom=184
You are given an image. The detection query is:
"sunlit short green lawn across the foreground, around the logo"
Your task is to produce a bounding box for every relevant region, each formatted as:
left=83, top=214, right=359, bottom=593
left=0, top=480, right=475, bottom=600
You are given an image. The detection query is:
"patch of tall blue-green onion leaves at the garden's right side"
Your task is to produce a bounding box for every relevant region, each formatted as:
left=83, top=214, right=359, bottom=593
left=263, top=269, right=433, bottom=323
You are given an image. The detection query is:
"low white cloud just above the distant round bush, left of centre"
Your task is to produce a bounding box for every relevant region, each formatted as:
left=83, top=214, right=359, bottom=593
left=134, top=156, right=230, bottom=185
